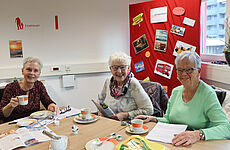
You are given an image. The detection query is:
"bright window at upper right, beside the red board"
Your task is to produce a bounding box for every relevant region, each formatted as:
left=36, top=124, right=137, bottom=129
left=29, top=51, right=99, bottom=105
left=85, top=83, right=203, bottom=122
left=200, top=0, right=226, bottom=55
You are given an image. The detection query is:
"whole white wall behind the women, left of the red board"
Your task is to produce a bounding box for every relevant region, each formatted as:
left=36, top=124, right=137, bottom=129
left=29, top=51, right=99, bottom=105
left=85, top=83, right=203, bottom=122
left=0, top=0, right=147, bottom=111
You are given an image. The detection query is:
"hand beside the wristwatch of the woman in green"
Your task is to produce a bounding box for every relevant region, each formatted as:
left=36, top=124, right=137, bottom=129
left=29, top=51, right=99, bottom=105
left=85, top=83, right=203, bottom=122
left=172, top=130, right=200, bottom=146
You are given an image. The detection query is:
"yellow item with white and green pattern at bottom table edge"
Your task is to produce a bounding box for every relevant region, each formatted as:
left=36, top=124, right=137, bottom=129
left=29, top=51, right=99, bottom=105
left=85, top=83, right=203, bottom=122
left=115, top=135, right=169, bottom=150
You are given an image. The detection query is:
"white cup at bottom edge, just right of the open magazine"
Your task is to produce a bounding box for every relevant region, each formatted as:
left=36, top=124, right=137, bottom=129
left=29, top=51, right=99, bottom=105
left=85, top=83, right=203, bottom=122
left=49, top=135, right=68, bottom=150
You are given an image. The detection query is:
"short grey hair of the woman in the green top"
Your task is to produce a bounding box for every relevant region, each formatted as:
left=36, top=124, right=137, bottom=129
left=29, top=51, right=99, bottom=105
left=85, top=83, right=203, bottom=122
left=175, top=51, right=201, bottom=68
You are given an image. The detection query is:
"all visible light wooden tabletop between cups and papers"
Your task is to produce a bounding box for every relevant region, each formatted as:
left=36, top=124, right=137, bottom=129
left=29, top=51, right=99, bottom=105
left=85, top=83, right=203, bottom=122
left=0, top=117, right=230, bottom=150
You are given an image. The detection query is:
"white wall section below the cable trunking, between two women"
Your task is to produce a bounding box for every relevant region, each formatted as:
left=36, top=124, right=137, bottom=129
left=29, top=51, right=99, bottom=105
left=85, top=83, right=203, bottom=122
left=40, top=73, right=110, bottom=111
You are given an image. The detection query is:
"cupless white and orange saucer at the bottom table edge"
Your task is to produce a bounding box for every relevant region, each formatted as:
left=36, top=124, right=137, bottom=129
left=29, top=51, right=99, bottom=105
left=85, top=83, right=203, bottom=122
left=85, top=138, right=118, bottom=150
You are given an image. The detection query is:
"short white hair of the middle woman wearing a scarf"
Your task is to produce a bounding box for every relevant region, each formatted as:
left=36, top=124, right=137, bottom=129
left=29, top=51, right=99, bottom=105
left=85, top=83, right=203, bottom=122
left=109, top=52, right=131, bottom=66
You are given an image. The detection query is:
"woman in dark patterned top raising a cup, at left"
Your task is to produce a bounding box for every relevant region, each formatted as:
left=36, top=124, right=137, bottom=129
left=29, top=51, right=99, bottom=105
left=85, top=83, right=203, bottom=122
left=0, top=57, right=59, bottom=122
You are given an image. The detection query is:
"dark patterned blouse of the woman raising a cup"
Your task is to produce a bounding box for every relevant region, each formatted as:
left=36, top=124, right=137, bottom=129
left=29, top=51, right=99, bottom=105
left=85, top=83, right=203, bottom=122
left=0, top=81, right=54, bottom=122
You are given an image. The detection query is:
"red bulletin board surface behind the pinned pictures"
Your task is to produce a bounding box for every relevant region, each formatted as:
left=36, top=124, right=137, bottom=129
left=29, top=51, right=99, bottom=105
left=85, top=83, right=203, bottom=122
left=129, top=0, right=201, bottom=96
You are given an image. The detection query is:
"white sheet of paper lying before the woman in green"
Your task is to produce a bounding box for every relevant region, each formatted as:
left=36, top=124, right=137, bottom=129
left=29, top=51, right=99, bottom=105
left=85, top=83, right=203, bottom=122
left=145, top=122, right=187, bottom=143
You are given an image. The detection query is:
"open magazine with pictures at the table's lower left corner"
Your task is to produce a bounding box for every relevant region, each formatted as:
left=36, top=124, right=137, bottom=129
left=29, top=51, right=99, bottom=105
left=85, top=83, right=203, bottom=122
left=0, top=128, right=50, bottom=150
